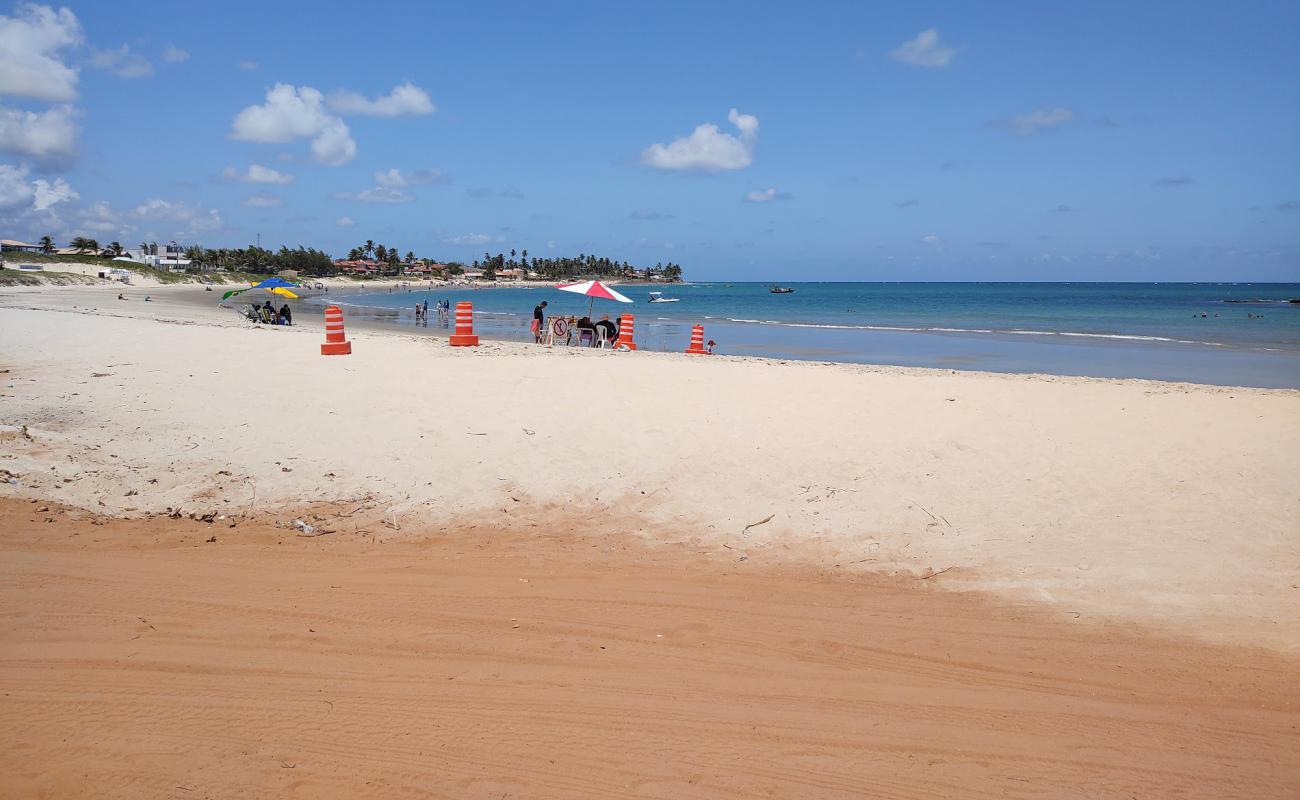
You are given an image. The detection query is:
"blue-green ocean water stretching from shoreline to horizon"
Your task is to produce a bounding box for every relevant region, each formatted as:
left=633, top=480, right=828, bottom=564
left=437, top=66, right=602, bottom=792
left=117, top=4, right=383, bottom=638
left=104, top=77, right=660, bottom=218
left=306, top=282, right=1300, bottom=388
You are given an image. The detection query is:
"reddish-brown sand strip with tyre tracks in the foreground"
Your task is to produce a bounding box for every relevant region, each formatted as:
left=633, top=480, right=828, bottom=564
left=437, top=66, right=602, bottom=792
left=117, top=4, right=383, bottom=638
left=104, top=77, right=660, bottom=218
left=0, top=500, right=1300, bottom=800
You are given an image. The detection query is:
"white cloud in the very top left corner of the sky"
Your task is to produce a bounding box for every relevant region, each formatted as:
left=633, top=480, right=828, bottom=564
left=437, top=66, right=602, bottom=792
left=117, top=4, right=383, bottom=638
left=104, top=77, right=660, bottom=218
left=0, top=3, right=82, bottom=103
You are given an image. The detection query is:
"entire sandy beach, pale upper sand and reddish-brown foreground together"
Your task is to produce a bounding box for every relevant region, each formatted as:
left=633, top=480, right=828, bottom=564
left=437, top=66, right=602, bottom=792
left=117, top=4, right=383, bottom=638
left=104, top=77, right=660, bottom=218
left=0, top=287, right=1300, bottom=797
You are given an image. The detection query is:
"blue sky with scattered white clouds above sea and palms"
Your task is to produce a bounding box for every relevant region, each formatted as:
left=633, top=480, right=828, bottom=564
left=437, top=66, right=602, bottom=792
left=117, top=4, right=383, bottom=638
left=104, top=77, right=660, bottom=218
left=0, top=0, right=1300, bottom=281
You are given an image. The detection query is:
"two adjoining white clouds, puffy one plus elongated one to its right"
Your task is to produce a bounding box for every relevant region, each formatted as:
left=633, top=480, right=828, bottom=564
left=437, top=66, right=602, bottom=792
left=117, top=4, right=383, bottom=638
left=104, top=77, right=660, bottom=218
left=230, top=82, right=436, bottom=167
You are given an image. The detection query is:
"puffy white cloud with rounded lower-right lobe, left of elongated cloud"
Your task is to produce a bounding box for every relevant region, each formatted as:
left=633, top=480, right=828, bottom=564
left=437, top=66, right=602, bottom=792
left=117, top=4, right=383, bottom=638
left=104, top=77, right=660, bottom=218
left=230, top=83, right=356, bottom=167
